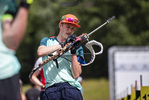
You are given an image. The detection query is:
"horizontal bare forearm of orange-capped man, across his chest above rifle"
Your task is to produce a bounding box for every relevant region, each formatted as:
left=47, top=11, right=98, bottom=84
left=37, top=45, right=61, bottom=57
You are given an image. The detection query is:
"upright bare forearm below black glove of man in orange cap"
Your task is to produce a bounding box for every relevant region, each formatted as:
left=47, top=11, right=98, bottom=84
left=71, top=54, right=82, bottom=79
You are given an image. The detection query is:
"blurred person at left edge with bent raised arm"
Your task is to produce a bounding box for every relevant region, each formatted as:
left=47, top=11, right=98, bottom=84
left=0, top=0, right=32, bottom=100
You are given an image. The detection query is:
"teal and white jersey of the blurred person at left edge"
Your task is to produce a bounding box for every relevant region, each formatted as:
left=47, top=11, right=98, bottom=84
left=0, top=3, right=21, bottom=80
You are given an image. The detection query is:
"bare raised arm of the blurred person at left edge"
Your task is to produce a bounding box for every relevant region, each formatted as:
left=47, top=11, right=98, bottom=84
left=3, top=7, right=28, bottom=50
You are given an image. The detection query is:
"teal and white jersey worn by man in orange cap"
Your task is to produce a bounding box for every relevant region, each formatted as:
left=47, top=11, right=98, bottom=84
left=40, top=37, right=84, bottom=90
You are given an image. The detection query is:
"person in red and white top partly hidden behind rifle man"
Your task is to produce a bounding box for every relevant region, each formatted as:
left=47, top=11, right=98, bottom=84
left=30, top=57, right=46, bottom=100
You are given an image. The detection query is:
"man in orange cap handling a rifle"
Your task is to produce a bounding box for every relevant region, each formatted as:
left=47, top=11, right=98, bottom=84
left=38, top=14, right=84, bottom=100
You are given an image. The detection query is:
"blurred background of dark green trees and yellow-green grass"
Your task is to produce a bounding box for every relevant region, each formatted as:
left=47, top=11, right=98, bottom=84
left=17, top=0, right=149, bottom=100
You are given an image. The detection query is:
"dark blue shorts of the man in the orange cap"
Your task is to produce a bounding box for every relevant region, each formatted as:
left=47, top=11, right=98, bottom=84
left=43, top=82, right=83, bottom=100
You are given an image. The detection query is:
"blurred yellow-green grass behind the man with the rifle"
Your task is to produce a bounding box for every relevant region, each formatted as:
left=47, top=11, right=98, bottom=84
left=23, top=78, right=109, bottom=100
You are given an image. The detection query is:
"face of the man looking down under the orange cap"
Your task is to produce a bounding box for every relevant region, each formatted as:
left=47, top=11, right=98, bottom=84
left=59, top=23, right=76, bottom=39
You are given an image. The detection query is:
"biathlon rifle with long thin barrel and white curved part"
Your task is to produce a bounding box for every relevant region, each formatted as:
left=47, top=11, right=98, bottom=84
left=29, top=16, right=115, bottom=78
